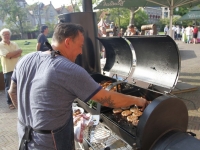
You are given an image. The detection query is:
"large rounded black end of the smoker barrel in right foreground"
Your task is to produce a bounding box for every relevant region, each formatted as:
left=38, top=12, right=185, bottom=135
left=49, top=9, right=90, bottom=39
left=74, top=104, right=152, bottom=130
left=136, top=96, right=188, bottom=150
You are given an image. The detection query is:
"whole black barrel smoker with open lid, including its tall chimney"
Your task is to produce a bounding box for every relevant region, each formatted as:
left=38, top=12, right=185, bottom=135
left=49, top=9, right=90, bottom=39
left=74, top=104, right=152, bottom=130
left=59, top=0, right=200, bottom=150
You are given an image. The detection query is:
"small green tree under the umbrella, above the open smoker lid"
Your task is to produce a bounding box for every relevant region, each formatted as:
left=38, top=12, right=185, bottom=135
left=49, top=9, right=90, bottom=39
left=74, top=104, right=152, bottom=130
left=134, top=9, right=148, bottom=30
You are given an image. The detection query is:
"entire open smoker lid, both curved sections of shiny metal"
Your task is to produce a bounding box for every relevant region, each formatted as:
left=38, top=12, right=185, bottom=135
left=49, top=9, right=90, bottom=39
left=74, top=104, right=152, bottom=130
left=98, top=36, right=180, bottom=90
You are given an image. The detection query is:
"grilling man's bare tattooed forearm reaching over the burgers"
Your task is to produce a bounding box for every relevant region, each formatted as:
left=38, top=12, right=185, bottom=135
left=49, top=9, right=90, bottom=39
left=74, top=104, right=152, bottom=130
left=92, top=89, right=148, bottom=110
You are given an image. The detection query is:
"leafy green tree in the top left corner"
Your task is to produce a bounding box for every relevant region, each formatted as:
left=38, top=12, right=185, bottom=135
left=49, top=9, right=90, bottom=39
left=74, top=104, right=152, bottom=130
left=0, top=0, right=27, bottom=38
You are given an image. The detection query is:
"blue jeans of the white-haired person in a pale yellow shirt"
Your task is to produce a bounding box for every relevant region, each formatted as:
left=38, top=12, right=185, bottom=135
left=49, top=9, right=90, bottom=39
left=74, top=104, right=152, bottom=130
left=3, top=71, right=13, bottom=105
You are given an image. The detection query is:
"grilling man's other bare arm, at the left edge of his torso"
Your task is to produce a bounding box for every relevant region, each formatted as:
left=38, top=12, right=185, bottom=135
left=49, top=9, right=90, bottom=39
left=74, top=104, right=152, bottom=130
left=8, top=80, right=17, bottom=108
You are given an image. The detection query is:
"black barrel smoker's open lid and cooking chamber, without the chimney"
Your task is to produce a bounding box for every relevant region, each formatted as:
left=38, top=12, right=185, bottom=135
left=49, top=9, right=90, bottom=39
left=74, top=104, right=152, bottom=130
left=95, top=36, right=200, bottom=150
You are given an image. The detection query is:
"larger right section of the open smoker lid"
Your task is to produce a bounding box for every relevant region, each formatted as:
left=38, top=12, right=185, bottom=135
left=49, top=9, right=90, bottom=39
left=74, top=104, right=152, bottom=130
left=127, top=36, right=180, bottom=89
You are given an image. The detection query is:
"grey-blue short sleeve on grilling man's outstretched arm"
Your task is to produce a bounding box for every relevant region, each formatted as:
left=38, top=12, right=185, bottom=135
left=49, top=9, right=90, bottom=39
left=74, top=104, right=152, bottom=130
left=57, top=64, right=102, bottom=101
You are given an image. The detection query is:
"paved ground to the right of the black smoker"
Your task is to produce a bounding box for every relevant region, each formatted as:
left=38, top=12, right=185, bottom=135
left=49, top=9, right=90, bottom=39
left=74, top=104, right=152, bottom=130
left=176, top=42, right=200, bottom=139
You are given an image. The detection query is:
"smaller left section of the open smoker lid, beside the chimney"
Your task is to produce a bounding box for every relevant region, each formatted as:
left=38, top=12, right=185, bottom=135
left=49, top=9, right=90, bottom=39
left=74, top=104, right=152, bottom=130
left=98, top=37, right=133, bottom=77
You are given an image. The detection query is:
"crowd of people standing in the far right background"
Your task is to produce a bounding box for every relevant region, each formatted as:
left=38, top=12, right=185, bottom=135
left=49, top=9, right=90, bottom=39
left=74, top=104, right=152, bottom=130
left=164, top=25, right=198, bottom=44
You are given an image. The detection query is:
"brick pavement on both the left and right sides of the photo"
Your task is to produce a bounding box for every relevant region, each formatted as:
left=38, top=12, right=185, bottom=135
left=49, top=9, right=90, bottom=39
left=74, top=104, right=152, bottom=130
left=0, top=41, right=200, bottom=150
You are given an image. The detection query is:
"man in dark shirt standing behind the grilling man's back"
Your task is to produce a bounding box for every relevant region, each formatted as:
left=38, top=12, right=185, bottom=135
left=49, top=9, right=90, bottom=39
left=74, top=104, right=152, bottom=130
left=36, top=26, right=49, bottom=51
